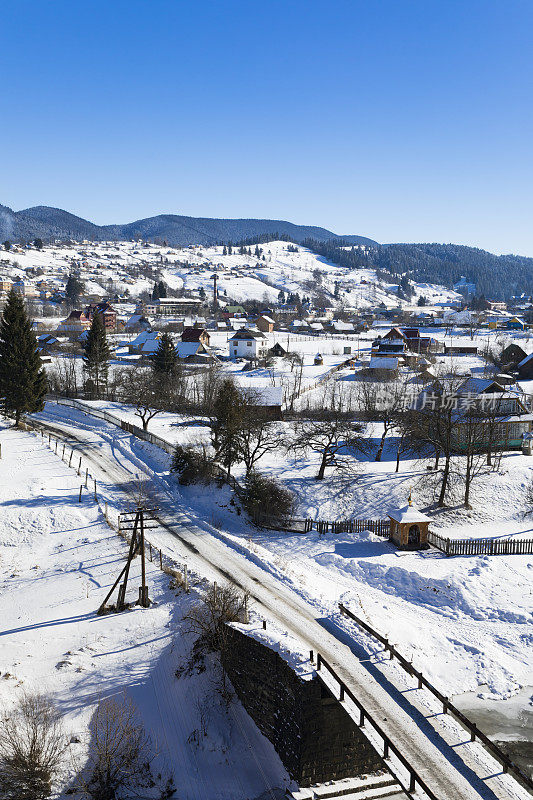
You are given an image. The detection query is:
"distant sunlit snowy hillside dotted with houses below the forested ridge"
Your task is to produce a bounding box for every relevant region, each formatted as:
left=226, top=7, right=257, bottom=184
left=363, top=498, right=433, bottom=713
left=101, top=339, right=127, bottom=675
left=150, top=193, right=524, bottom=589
left=0, top=241, right=459, bottom=309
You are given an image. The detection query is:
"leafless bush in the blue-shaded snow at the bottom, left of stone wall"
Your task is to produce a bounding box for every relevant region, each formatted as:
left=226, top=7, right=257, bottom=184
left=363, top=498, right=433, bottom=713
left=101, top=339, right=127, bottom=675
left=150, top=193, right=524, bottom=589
left=78, top=696, right=175, bottom=800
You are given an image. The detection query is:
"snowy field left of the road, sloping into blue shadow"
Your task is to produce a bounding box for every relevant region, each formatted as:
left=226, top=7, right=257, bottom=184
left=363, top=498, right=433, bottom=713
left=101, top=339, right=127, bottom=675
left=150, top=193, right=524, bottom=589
left=0, top=426, right=288, bottom=800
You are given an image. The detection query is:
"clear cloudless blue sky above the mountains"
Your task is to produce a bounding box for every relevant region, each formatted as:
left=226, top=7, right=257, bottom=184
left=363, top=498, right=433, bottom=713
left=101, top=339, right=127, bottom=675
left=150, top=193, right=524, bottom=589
left=0, top=0, right=533, bottom=256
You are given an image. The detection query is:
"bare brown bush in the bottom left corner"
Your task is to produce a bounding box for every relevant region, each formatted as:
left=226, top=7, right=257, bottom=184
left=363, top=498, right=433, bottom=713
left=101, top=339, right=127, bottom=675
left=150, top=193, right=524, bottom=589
left=0, top=695, right=66, bottom=800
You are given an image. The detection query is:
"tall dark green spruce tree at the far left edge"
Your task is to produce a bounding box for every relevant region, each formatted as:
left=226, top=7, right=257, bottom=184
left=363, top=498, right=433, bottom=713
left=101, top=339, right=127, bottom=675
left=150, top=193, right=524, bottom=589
left=0, top=289, right=48, bottom=426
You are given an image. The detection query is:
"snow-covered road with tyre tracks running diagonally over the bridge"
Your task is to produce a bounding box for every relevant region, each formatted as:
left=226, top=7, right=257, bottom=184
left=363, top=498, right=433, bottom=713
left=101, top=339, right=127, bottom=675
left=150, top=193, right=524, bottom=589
left=29, top=404, right=530, bottom=800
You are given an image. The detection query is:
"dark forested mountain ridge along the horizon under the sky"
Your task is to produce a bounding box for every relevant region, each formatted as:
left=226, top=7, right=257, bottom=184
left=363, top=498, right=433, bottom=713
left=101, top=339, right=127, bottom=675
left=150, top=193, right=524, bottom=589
left=0, top=205, right=533, bottom=300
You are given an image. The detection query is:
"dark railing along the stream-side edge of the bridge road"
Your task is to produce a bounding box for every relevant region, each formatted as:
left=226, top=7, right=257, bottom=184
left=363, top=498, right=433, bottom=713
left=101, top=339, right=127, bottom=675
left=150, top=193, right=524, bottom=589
left=339, top=603, right=533, bottom=791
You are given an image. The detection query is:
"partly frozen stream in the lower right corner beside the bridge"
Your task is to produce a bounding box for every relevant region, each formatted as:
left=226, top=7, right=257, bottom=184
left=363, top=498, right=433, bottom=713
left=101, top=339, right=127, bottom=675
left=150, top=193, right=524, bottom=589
left=454, top=686, right=533, bottom=776
